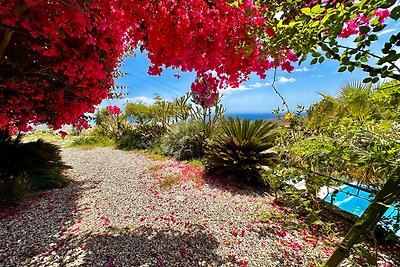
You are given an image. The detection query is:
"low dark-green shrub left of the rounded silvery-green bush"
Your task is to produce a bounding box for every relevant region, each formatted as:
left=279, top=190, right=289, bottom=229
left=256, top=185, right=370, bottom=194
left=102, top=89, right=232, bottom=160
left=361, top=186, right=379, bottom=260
left=116, top=124, right=165, bottom=149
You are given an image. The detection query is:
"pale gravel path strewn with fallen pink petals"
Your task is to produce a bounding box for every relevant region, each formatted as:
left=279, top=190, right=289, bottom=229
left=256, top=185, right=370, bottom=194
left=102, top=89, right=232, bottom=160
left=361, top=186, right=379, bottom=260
left=0, top=148, right=398, bottom=266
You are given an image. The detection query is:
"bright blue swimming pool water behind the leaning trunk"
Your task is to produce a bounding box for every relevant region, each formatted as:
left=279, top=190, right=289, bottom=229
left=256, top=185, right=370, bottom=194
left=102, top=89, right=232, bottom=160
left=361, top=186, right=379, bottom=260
left=325, top=186, right=400, bottom=236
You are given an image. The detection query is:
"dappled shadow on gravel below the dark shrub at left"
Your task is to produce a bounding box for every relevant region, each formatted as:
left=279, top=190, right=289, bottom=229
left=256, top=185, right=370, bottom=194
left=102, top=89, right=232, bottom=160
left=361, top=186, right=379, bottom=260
left=0, top=181, right=92, bottom=266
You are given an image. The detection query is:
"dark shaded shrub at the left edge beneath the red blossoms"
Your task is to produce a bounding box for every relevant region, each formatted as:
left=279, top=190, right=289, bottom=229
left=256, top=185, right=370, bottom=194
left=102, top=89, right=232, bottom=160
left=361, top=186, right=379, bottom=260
left=0, top=136, right=68, bottom=200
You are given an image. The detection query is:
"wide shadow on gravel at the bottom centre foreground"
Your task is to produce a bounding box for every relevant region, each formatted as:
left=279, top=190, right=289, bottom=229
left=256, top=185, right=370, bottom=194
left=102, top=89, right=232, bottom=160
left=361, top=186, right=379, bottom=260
left=83, top=225, right=229, bottom=266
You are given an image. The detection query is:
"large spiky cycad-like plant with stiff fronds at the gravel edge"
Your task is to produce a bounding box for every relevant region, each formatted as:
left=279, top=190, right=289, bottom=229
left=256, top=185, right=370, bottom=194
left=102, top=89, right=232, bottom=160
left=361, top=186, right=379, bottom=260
left=205, top=117, right=278, bottom=183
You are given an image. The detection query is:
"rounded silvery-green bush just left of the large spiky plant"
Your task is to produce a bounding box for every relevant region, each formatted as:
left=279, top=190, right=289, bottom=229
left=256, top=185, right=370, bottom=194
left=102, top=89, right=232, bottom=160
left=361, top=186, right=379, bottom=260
left=161, top=121, right=209, bottom=160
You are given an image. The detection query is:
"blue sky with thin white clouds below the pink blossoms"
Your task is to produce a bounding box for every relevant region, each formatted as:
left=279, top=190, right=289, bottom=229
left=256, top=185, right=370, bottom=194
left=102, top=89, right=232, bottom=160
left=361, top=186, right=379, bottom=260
left=101, top=18, right=400, bottom=113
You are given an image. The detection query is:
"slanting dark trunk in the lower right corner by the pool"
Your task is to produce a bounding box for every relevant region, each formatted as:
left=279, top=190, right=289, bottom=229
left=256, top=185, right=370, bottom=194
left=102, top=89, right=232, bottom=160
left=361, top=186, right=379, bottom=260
left=326, top=177, right=400, bottom=267
